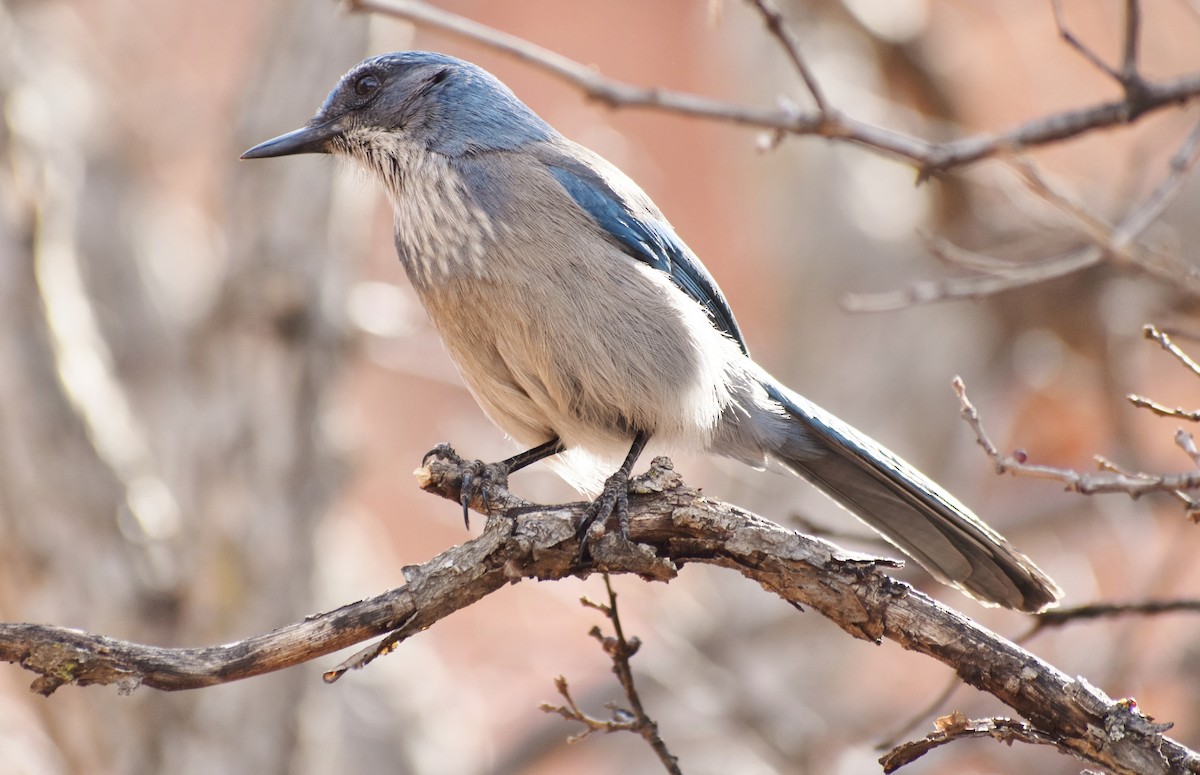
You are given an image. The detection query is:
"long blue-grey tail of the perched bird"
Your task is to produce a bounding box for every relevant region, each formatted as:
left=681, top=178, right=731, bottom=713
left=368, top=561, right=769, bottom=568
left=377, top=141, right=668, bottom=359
left=764, top=383, right=1062, bottom=612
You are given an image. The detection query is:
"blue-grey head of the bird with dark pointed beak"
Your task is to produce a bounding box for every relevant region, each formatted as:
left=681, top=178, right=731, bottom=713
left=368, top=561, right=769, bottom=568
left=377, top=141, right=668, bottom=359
left=242, top=52, right=554, bottom=158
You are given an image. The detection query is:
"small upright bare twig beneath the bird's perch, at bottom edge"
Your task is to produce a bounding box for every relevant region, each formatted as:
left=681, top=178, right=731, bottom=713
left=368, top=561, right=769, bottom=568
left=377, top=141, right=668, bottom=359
left=540, top=573, right=682, bottom=775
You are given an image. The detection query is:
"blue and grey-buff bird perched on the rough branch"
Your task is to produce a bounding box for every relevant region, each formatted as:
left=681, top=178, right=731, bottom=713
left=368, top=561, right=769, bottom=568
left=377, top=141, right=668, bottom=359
left=241, top=50, right=1062, bottom=613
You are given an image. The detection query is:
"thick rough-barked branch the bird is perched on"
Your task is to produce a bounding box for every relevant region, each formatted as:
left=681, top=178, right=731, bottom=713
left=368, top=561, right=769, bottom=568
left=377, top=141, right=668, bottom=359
left=0, top=458, right=1200, bottom=774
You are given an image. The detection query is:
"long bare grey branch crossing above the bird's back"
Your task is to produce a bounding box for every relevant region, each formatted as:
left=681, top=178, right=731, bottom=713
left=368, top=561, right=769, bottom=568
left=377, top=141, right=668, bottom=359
left=346, top=0, right=1200, bottom=180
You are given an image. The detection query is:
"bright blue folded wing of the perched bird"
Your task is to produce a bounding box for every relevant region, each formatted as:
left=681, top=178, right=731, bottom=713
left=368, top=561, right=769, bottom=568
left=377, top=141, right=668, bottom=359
left=548, top=163, right=746, bottom=353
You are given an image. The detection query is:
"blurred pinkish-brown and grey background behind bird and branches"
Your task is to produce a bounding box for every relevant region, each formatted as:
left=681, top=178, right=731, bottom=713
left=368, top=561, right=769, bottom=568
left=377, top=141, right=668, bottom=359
left=0, top=0, right=1200, bottom=775
